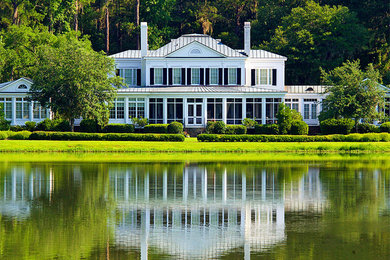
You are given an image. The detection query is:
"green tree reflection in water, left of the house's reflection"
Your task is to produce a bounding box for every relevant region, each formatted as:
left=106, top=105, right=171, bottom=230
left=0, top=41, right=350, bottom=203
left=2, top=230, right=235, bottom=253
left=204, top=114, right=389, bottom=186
left=0, top=164, right=112, bottom=259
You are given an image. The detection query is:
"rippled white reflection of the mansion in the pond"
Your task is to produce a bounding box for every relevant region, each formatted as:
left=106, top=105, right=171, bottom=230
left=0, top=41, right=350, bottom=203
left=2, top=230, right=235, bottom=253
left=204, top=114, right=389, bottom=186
left=110, top=165, right=323, bottom=259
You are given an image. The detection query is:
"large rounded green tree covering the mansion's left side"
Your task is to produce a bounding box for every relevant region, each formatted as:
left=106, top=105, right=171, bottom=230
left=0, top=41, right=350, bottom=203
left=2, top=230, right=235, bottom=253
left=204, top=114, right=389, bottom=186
left=29, top=34, right=121, bottom=131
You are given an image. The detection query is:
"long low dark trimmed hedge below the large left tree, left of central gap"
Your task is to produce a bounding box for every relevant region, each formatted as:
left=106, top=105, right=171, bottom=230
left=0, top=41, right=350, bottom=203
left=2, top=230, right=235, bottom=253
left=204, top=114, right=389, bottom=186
left=29, top=132, right=185, bottom=142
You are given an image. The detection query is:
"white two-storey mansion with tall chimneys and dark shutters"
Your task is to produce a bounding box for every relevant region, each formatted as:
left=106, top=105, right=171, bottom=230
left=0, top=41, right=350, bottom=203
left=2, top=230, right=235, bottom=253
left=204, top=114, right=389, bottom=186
left=0, top=23, right=332, bottom=128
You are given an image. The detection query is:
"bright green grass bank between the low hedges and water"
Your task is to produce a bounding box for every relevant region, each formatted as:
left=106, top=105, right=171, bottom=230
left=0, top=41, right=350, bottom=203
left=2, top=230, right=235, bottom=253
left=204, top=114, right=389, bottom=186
left=0, top=138, right=390, bottom=153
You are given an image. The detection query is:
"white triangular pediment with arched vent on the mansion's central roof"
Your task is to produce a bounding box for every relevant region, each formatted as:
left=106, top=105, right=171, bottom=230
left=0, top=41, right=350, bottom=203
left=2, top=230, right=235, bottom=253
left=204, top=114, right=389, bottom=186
left=166, top=41, right=226, bottom=58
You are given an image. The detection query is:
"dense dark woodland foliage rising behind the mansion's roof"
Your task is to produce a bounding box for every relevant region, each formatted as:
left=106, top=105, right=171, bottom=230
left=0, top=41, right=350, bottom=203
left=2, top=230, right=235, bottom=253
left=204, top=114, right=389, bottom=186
left=0, top=0, right=390, bottom=84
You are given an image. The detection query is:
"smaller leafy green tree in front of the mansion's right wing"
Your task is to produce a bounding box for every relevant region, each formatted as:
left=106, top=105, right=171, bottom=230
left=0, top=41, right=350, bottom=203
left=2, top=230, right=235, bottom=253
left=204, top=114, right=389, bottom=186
left=320, top=60, right=385, bottom=126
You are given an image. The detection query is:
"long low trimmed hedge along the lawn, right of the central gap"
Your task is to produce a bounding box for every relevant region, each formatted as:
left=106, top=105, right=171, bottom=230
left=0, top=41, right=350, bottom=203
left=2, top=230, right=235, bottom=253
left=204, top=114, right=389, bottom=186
left=198, top=133, right=390, bottom=142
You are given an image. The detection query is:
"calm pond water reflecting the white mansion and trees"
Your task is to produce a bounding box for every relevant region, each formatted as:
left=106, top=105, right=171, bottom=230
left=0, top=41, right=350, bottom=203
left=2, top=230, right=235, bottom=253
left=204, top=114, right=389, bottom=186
left=0, top=157, right=390, bottom=259
